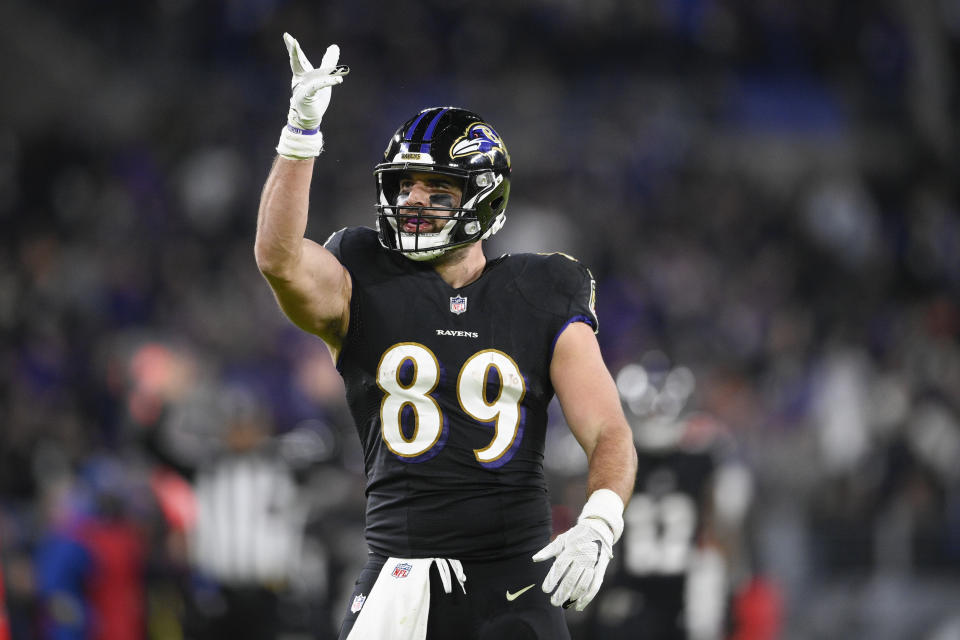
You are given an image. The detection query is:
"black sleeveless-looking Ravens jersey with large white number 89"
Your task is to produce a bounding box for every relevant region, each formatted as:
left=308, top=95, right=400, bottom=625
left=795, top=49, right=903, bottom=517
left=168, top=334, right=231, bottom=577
left=325, top=227, right=597, bottom=560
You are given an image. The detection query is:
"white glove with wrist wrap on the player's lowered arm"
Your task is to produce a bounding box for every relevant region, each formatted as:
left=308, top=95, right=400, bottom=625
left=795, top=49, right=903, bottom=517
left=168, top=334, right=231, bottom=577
left=533, top=489, right=623, bottom=611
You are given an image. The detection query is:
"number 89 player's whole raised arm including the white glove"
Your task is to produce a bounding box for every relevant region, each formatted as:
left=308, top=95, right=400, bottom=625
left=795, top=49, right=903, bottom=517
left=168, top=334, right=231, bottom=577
left=254, top=34, right=351, bottom=356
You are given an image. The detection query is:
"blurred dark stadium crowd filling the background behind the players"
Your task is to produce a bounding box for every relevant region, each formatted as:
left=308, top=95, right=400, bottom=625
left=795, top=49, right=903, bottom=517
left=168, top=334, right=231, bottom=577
left=0, top=0, right=960, bottom=640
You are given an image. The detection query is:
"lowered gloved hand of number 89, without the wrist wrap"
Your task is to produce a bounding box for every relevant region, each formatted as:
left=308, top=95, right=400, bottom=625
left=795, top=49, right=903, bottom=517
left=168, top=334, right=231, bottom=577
left=533, top=518, right=613, bottom=611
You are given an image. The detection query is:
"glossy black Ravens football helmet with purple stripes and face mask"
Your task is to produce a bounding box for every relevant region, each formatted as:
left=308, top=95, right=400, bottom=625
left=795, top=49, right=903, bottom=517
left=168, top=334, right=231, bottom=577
left=373, top=107, right=510, bottom=260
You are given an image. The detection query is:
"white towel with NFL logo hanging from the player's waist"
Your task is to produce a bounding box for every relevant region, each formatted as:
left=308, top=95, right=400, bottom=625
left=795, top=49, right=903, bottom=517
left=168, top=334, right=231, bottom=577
left=347, top=558, right=467, bottom=640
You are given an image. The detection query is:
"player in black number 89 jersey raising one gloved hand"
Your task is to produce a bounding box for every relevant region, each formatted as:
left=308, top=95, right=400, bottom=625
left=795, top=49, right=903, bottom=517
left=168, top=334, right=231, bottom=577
left=255, top=34, right=636, bottom=640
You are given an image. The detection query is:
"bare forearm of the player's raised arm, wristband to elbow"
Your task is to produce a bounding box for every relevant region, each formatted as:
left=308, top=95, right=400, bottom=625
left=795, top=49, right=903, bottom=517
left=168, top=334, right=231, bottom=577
left=254, top=156, right=314, bottom=276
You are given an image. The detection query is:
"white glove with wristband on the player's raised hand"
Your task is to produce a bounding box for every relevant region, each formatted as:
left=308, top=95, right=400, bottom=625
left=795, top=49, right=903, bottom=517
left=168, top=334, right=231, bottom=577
left=277, top=33, right=350, bottom=158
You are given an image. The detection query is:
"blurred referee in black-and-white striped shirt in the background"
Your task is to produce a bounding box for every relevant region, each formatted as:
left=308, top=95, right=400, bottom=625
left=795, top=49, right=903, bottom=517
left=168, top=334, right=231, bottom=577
left=148, top=389, right=318, bottom=640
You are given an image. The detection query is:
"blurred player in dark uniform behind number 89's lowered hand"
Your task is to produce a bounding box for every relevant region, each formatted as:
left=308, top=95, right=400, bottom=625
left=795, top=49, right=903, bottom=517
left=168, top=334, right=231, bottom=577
left=587, top=352, right=752, bottom=640
